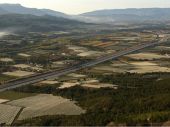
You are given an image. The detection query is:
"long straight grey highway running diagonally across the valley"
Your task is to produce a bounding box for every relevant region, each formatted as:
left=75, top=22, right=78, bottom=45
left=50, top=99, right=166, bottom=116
left=0, top=38, right=166, bottom=92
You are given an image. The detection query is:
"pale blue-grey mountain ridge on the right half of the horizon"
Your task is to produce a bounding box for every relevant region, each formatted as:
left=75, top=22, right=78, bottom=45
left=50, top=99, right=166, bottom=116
left=81, top=8, right=170, bottom=22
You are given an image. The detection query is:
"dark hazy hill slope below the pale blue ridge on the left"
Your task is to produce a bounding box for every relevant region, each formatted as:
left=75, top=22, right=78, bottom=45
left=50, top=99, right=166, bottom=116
left=0, top=14, right=87, bottom=32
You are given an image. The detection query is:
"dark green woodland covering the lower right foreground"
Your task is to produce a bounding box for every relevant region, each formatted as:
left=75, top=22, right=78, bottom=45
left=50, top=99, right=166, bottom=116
left=11, top=73, right=169, bottom=126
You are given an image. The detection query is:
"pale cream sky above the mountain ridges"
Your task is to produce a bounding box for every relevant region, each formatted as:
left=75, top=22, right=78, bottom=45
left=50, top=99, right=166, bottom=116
left=0, top=0, right=170, bottom=14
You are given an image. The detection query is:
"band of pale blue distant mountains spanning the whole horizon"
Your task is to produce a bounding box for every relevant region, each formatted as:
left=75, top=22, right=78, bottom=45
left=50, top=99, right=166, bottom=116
left=0, top=4, right=170, bottom=23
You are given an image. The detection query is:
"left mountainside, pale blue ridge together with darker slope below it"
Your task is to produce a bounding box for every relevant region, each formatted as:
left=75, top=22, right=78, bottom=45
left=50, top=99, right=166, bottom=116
left=0, top=4, right=90, bottom=32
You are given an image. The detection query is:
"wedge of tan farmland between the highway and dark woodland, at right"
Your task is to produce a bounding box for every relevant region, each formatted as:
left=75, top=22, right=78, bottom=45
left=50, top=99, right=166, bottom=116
left=88, top=40, right=170, bottom=74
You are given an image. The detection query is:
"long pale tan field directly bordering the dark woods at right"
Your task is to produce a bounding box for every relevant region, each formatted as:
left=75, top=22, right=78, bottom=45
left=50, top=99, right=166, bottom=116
left=90, top=61, right=170, bottom=74
